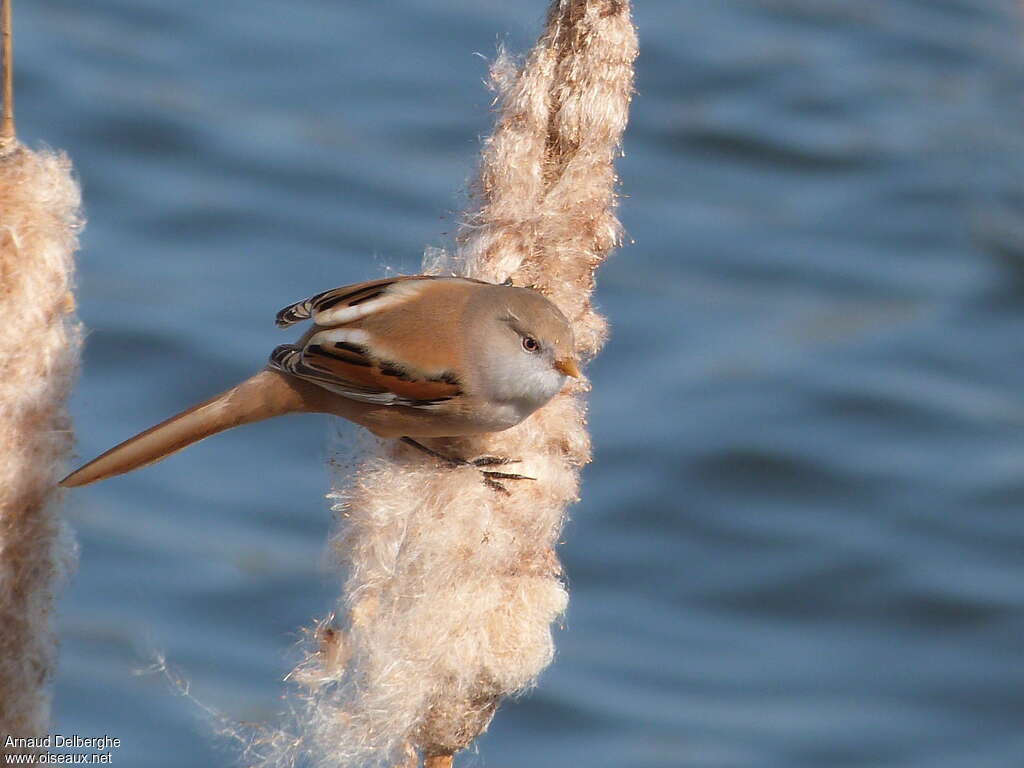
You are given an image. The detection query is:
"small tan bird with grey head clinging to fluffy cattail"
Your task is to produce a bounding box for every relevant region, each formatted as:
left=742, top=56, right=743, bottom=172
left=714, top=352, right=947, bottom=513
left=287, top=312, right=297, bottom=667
left=60, top=275, right=580, bottom=487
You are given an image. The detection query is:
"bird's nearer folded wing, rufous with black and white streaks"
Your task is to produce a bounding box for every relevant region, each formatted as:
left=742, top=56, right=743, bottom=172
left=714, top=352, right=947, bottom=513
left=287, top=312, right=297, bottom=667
left=270, top=329, right=462, bottom=408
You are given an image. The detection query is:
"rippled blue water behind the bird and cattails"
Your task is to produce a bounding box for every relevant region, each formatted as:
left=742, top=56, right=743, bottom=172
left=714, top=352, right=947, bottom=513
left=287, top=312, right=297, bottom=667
left=16, top=0, right=1024, bottom=768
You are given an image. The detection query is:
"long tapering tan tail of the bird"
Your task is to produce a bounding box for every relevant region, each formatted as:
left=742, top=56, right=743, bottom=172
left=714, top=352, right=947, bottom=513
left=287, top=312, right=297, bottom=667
left=60, top=371, right=315, bottom=487
